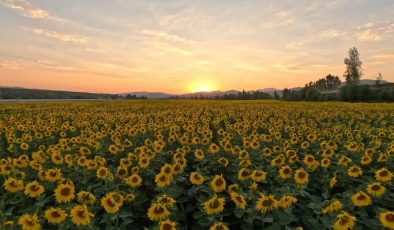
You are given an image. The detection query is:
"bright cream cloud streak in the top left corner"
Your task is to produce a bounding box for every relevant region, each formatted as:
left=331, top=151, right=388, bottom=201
left=2, top=0, right=62, bottom=21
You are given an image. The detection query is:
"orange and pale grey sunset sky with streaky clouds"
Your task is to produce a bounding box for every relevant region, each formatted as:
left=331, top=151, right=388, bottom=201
left=0, top=0, right=394, bottom=93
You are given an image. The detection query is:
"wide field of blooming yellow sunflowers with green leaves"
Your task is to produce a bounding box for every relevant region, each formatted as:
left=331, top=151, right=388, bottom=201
left=0, top=100, right=394, bottom=230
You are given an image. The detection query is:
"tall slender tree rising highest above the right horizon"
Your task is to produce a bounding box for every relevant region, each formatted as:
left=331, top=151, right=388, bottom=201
left=344, top=47, right=362, bottom=84
